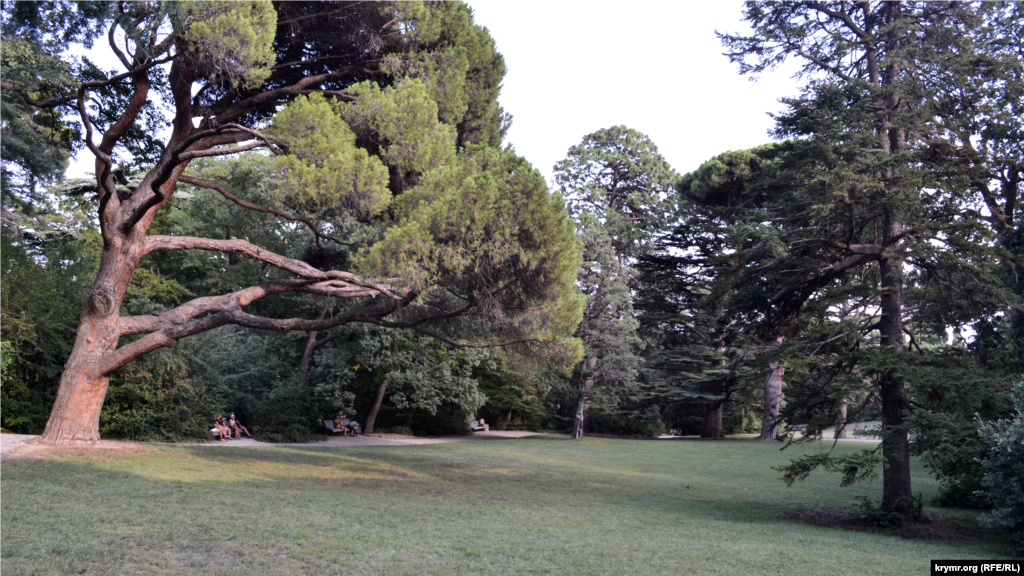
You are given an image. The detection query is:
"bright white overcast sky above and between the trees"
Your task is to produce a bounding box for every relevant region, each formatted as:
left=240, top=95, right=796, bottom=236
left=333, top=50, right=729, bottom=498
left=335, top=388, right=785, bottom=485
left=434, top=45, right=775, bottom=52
left=69, top=0, right=797, bottom=181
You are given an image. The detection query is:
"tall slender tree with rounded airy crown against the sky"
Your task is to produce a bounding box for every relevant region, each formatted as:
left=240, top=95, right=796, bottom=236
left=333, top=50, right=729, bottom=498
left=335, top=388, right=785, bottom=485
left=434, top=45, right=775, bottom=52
left=555, top=126, right=674, bottom=438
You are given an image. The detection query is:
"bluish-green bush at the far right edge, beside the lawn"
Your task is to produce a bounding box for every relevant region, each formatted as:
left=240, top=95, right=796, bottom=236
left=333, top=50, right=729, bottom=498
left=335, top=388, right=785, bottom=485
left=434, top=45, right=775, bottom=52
left=979, top=382, right=1024, bottom=550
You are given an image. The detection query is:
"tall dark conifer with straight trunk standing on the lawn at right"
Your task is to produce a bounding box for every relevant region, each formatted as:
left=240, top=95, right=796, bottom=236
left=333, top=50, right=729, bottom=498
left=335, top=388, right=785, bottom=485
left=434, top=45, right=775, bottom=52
left=721, top=0, right=1015, bottom=512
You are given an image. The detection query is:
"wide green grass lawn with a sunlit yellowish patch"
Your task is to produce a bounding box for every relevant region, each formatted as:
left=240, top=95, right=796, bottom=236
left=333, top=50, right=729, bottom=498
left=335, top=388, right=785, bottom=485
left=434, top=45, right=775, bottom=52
left=0, top=438, right=1007, bottom=576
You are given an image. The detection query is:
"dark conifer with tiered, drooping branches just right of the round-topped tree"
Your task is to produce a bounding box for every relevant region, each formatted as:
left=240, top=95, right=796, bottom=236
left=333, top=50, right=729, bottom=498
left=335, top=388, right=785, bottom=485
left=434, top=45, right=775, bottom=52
left=637, top=146, right=780, bottom=439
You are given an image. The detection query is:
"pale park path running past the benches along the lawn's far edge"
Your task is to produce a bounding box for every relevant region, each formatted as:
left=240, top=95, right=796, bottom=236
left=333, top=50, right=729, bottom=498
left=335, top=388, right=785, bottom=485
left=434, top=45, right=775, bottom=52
left=0, top=430, right=543, bottom=459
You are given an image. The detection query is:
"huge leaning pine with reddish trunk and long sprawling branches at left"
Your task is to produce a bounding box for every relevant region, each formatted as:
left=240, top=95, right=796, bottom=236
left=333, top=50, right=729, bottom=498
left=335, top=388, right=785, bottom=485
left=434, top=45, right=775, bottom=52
left=0, top=0, right=582, bottom=443
